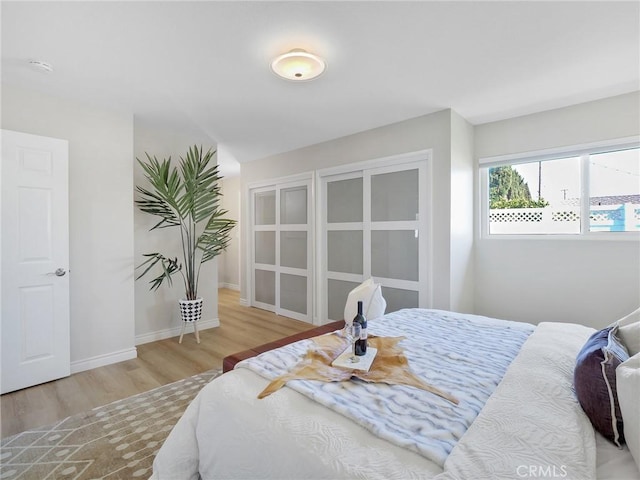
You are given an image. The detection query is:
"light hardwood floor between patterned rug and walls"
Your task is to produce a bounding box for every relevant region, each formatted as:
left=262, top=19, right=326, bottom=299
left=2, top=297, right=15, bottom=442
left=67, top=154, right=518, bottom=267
left=0, top=289, right=313, bottom=438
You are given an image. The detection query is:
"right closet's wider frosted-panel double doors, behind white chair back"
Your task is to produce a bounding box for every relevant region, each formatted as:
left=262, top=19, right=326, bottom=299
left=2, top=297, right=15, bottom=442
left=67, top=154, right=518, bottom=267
left=321, top=162, right=429, bottom=320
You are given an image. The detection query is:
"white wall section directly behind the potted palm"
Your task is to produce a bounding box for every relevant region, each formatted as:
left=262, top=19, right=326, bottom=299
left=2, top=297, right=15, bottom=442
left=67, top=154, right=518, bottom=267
left=131, top=119, right=220, bottom=344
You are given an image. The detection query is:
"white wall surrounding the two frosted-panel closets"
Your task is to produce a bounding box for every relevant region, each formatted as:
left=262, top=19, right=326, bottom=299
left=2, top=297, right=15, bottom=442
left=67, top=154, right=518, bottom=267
left=241, top=110, right=473, bottom=316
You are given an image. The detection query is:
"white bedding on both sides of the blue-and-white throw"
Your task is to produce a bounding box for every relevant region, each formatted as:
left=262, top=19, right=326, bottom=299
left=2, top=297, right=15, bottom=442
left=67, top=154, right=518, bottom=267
left=152, top=310, right=640, bottom=480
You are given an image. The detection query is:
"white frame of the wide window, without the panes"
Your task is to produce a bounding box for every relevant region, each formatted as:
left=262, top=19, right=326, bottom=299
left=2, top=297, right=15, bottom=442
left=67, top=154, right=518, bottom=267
left=478, top=136, right=640, bottom=241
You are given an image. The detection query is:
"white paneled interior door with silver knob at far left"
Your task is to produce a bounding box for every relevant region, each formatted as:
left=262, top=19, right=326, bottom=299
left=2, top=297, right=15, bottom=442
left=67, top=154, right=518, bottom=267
left=0, top=130, right=70, bottom=393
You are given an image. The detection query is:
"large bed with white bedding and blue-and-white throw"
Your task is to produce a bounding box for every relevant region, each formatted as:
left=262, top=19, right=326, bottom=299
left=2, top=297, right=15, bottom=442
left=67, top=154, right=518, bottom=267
left=152, top=309, right=640, bottom=480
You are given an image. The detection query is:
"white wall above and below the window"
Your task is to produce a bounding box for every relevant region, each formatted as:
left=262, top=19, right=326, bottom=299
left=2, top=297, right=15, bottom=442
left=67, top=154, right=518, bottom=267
left=475, top=92, right=640, bottom=328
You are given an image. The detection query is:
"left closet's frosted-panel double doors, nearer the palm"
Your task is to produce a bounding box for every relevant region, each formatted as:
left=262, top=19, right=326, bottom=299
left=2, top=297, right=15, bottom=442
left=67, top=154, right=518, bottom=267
left=251, top=180, right=313, bottom=322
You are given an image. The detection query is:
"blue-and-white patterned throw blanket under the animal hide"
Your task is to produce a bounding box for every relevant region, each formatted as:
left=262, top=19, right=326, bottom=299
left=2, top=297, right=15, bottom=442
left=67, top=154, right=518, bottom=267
left=236, top=309, right=535, bottom=466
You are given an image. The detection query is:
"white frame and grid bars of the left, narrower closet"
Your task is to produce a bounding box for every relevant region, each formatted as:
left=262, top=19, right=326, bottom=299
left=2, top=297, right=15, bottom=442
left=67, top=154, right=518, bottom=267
left=246, top=173, right=316, bottom=323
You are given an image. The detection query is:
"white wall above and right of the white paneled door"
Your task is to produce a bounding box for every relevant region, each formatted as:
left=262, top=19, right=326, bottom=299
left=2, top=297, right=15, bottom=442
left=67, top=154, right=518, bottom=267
left=2, top=85, right=136, bottom=372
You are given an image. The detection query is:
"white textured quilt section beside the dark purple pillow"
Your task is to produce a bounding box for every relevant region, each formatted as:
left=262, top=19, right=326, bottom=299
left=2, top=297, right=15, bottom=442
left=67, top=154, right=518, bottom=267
left=437, top=323, right=596, bottom=480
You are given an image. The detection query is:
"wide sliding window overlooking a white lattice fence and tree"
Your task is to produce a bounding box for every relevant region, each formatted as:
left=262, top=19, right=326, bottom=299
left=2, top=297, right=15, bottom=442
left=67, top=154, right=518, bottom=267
left=480, top=142, right=640, bottom=235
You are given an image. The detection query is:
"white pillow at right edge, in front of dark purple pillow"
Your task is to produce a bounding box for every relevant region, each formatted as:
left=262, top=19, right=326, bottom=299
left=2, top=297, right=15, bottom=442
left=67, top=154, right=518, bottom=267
left=616, top=354, right=640, bottom=469
